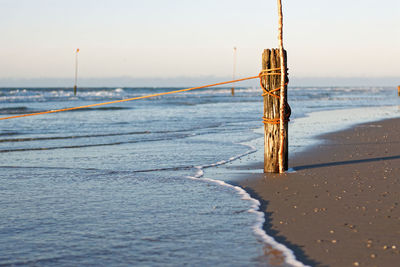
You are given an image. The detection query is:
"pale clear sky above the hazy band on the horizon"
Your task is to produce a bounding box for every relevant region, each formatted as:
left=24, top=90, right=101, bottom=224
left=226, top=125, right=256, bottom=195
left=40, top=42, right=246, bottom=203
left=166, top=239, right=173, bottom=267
left=0, top=0, right=400, bottom=83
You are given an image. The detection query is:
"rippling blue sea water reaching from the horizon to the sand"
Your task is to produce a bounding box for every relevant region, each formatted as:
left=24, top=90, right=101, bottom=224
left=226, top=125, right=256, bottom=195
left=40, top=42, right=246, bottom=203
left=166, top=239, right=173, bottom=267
left=0, top=87, right=400, bottom=266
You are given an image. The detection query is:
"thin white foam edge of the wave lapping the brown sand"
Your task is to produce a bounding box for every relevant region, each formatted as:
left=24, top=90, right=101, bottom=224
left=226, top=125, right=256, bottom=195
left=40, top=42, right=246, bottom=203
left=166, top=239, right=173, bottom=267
left=187, top=145, right=308, bottom=267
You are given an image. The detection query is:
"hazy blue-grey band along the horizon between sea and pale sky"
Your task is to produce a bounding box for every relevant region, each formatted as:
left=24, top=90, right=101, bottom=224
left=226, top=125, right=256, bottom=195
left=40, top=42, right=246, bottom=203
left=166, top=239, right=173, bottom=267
left=0, top=75, right=400, bottom=88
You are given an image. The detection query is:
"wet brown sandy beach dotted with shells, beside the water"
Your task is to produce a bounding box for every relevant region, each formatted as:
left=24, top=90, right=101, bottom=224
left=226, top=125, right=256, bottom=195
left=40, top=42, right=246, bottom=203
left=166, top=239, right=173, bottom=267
left=236, top=119, right=400, bottom=267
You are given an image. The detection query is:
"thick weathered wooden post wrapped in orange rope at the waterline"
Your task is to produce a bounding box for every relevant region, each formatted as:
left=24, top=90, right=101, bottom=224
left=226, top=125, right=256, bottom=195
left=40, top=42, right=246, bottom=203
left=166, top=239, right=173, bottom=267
left=261, top=49, right=290, bottom=173
